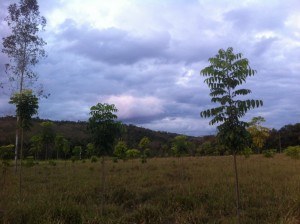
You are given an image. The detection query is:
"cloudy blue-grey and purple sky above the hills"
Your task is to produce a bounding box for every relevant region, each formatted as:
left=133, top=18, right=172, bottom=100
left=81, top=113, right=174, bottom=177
left=0, top=0, right=300, bottom=136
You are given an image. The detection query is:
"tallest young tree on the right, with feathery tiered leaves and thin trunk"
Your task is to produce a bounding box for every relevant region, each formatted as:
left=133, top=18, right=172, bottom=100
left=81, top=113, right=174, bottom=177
left=200, top=47, right=263, bottom=223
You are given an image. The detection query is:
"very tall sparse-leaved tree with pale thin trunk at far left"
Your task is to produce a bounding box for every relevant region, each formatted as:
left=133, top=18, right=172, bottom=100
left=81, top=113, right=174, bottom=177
left=2, top=0, right=46, bottom=168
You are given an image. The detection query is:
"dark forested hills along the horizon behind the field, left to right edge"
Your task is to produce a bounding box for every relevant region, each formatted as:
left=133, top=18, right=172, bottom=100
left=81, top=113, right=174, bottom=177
left=0, top=117, right=300, bottom=155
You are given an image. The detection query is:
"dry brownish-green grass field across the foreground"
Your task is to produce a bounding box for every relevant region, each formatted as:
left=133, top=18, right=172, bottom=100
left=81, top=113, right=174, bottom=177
left=0, top=155, right=300, bottom=224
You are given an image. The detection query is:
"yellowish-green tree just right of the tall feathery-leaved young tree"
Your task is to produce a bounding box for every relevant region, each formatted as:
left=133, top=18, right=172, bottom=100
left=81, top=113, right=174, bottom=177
left=247, top=116, right=270, bottom=153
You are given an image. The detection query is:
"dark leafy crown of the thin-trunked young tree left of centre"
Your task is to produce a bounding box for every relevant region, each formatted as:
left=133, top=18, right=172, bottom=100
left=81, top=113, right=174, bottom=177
left=88, top=103, right=123, bottom=155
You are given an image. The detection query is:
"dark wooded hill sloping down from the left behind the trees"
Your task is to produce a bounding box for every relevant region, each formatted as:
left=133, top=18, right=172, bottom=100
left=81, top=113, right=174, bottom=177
left=0, top=116, right=200, bottom=148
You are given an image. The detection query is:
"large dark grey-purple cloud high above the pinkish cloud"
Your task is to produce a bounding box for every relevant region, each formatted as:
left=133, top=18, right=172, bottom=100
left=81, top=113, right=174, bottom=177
left=56, top=21, right=170, bottom=64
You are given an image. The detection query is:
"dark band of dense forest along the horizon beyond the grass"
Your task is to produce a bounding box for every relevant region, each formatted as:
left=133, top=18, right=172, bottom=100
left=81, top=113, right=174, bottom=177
left=0, top=116, right=300, bottom=159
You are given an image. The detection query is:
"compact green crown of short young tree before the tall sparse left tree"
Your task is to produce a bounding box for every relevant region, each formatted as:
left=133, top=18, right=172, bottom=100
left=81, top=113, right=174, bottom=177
left=9, top=90, right=39, bottom=129
